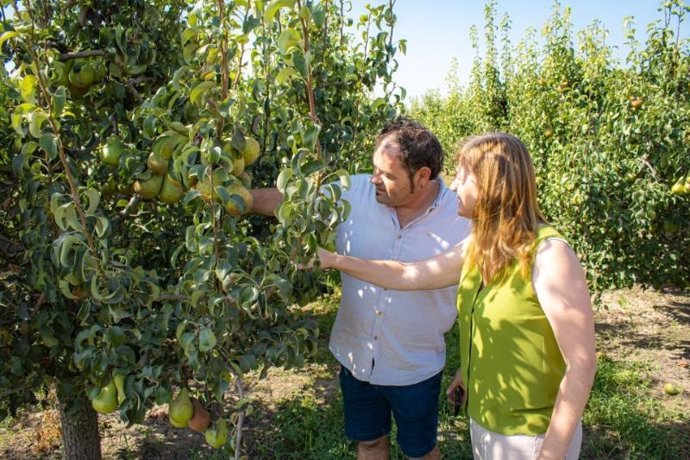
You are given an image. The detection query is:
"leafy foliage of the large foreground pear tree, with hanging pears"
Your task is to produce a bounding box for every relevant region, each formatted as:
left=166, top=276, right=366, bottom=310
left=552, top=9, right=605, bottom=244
left=0, top=0, right=404, bottom=450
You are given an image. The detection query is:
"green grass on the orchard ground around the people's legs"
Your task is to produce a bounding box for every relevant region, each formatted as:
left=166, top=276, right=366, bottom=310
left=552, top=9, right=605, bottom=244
left=245, top=300, right=690, bottom=460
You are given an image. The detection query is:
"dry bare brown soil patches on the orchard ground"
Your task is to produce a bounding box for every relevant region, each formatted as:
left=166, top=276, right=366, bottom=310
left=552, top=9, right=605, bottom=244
left=0, top=289, right=690, bottom=459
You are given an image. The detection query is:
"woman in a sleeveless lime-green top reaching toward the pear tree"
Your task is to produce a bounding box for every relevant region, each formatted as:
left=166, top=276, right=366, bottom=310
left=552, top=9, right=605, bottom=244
left=319, top=133, right=596, bottom=459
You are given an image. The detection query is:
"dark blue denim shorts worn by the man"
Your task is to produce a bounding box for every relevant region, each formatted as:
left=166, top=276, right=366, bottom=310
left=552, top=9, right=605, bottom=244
left=340, top=366, right=441, bottom=457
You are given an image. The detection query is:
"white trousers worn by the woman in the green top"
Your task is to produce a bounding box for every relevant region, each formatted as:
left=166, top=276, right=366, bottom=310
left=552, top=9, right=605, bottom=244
left=470, top=418, right=582, bottom=460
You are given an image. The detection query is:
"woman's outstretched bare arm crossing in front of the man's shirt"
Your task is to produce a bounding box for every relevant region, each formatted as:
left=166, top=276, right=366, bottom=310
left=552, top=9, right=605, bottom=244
left=319, top=240, right=466, bottom=291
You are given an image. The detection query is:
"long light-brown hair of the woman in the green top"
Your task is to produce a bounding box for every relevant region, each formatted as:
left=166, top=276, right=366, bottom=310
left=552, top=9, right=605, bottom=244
left=458, top=133, right=545, bottom=283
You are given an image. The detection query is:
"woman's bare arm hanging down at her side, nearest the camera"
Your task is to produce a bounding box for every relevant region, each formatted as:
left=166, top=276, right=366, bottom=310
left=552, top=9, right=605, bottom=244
left=532, top=240, right=596, bottom=459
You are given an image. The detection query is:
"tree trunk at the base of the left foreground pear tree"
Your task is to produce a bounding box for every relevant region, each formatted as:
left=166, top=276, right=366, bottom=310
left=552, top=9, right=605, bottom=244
left=59, top=396, right=101, bottom=460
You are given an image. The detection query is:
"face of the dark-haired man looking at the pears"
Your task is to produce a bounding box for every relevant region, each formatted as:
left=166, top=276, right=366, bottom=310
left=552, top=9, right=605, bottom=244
left=371, top=134, right=413, bottom=207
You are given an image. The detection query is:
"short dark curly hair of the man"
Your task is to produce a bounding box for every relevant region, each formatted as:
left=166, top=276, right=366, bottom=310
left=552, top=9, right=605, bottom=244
left=376, top=116, right=443, bottom=180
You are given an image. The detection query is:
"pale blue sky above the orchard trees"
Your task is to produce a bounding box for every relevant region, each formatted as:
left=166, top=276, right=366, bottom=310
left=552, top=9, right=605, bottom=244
left=352, top=0, right=690, bottom=101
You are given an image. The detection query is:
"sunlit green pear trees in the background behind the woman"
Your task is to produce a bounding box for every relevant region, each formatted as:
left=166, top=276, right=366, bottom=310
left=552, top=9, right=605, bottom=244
left=411, top=1, right=690, bottom=291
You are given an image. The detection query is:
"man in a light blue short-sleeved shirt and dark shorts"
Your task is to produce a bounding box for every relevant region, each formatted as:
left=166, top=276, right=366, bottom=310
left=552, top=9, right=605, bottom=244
left=252, top=118, right=470, bottom=460
